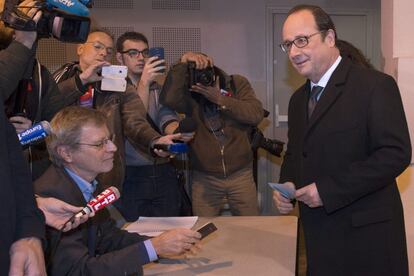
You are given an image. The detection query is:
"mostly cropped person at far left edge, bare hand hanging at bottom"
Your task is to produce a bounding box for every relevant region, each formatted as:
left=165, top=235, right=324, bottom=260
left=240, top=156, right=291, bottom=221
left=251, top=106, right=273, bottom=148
left=0, top=1, right=46, bottom=275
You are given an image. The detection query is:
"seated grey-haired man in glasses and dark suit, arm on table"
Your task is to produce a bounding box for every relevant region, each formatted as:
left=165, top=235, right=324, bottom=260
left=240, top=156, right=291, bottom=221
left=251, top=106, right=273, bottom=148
left=35, top=106, right=200, bottom=275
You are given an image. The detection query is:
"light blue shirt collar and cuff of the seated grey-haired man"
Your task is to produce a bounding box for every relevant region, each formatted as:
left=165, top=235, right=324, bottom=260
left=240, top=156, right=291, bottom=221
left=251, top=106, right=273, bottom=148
left=65, top=167, right=158, bottom=262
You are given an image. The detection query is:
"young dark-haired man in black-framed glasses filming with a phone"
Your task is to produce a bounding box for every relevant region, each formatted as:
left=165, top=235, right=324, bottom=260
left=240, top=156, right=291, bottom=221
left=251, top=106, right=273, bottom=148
left=115, top=32, right=191, bottom=221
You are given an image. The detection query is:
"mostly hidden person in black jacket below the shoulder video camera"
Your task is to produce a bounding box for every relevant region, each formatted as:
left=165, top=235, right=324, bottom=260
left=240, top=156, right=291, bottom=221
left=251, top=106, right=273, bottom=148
left=0, top=4, right=66, bottom=180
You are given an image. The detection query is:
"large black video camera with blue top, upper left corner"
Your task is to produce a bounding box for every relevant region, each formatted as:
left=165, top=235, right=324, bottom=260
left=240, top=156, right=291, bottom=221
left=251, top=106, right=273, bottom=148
left=1, top=0, right=92, bottom=43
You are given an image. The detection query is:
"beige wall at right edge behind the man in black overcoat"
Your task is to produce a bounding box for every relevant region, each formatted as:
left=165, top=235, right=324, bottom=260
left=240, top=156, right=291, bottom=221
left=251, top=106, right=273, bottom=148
left=381, top=0, right=414, bottom=274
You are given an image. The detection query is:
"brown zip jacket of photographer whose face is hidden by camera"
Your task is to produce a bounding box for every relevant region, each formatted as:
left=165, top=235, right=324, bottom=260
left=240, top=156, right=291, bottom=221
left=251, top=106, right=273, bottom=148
left=160, top=63, right=263, bottom=177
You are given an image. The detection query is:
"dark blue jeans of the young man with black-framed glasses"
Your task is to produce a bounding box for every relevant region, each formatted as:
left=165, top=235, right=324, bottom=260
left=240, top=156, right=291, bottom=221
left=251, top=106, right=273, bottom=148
left=115, top=163, right=181, bottom=221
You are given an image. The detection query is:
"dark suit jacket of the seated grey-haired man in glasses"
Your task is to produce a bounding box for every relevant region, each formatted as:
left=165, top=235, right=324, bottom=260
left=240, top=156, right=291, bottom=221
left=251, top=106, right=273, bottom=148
left=35, top=166, right=149, bottom=275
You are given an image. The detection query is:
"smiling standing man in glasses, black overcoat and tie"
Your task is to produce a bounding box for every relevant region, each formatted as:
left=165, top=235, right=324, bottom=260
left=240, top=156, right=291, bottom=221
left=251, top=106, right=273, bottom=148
left=273, top=5, right=411, bottom=276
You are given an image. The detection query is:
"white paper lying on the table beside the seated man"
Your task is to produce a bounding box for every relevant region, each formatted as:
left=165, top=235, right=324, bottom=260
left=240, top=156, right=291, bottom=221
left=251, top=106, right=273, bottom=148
left=125, top=216, right=198, bottom=237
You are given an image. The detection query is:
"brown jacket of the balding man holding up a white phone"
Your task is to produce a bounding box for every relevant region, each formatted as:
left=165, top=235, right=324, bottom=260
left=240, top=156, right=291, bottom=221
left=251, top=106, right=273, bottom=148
left=53, top=63, right=161, bottom=190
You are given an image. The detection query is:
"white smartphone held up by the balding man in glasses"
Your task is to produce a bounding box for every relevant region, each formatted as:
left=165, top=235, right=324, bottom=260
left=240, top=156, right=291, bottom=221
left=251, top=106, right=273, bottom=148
left=101, top=65, right=128, bottom=92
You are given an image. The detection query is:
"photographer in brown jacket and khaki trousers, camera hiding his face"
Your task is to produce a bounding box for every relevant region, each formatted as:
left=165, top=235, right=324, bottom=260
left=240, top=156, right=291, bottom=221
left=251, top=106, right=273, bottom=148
left=160, top=53, right=263, bottom=216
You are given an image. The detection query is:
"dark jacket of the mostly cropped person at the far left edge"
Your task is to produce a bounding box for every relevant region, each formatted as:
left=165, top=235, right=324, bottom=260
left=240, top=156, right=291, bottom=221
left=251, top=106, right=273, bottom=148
left=0, top=42, right=44, bottom=275
